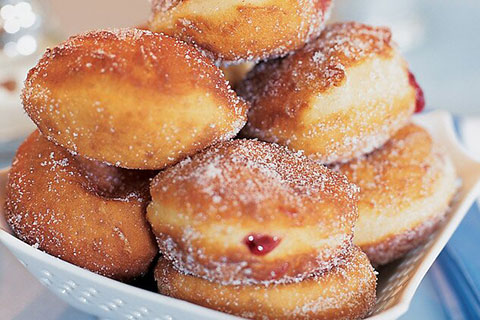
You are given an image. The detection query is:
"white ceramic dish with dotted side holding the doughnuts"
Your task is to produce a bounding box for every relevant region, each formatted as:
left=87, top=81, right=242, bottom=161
left=0, top=111, right=480, bottom=320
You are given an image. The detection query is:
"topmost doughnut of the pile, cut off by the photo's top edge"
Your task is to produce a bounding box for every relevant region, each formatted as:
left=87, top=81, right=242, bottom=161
left=150, top=0, right=332, bottom=61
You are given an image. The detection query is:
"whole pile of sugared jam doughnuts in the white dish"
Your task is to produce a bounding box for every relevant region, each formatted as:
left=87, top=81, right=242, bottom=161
left=6, top=0, right=462, bottom=319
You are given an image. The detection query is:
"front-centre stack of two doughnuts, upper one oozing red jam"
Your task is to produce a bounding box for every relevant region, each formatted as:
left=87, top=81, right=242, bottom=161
left=147, top=140, right=376, bottom=319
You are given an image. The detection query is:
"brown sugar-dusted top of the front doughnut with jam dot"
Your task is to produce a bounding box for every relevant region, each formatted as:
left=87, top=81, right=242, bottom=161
left=151, top=139, right=357, bottom=215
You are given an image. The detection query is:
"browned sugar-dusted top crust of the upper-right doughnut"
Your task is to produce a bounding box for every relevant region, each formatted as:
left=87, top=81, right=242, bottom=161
left=242, top=22, right=393, bottom=106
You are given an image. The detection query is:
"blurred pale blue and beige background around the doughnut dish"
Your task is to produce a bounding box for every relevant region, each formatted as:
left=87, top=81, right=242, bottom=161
left=0, top=0, right=480, bottom=319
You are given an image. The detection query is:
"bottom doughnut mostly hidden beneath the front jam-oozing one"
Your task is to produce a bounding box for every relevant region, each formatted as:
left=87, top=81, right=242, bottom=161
left=155, top=248, right=376, bottom=320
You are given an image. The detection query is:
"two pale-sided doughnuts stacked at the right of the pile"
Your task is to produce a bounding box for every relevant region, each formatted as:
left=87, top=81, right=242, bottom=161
left=238, top=22, right=457, bottom=265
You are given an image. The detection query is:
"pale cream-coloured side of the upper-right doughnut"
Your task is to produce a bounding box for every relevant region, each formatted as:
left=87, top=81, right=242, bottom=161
left=296, top=54, right=412, bottom=163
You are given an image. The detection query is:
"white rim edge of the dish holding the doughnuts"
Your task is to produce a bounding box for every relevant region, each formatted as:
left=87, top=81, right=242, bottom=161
left=0, top=111, right=480, bottom=320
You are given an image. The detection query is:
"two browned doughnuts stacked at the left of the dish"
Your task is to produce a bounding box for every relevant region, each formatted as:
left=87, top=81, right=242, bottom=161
left=6, top=29, right=247, bottom=281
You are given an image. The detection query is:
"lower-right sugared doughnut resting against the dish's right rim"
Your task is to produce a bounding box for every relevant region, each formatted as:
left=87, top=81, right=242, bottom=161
left=338, top=124, right=458, bottom=265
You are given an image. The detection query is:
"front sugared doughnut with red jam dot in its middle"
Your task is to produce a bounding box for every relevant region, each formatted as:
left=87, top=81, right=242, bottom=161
left=147, top=140, right=357, bottom=284
